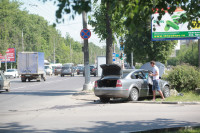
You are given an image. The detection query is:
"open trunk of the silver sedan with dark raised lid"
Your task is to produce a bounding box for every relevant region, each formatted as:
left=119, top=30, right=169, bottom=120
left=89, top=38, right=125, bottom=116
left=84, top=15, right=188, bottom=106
left=97, top=64, right=122, bottom=87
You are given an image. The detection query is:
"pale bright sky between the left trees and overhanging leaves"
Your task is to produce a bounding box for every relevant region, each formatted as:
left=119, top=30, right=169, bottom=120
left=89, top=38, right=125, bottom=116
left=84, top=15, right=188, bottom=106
left=18, top=0, right=106, bottom=47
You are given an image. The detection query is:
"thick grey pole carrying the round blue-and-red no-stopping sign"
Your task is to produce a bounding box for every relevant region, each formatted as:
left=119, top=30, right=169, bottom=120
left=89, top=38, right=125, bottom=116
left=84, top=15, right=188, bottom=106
left=82, top=11, right=90, bottom=90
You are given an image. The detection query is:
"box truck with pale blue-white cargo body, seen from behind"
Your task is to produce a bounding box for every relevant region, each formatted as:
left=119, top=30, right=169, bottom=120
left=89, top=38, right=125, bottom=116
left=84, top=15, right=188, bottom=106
left=17, top=52, right=46, bottom=82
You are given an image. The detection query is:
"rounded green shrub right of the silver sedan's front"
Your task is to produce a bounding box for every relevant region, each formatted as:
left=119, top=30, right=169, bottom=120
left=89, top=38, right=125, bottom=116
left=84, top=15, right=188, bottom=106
left=167, top=65, right=200, bottom=91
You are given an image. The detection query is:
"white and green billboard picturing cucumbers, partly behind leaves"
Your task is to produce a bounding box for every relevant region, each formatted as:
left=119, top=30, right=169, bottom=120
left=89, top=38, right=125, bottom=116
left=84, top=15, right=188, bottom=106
left=151, top=8, right=200, bottom=41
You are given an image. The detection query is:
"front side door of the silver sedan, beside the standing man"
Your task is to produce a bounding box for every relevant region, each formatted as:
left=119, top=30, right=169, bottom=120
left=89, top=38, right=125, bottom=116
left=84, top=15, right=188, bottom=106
left=131, top=71, right=148, bottom=96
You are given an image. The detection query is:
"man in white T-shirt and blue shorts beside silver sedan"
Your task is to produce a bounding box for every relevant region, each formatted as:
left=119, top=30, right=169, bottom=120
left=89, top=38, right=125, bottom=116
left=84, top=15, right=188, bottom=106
left=149, top=61, right=165, bottom=101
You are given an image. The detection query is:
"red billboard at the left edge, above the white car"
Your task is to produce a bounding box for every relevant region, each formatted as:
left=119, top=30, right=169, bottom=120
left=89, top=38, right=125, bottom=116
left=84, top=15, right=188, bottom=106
left=0, top=48, right=16, bottom=63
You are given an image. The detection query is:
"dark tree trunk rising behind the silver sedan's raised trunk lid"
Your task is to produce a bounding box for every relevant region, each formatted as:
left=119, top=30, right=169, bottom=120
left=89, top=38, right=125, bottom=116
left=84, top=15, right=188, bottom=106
left=106, top=1, right=113, bottom=64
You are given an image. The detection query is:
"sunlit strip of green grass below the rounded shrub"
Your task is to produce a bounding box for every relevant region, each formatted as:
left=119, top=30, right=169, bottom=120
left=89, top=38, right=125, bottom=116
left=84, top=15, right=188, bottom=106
left=156, top=92, right=200, bottom=102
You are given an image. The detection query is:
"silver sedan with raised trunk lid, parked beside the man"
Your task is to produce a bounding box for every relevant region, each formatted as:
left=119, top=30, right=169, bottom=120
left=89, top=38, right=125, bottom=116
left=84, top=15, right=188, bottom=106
left=94, top=64, right=170, bottom=103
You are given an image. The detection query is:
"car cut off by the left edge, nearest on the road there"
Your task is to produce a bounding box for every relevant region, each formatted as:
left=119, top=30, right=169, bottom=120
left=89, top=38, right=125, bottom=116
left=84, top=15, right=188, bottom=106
left=0, top=70, right=10, bottom=93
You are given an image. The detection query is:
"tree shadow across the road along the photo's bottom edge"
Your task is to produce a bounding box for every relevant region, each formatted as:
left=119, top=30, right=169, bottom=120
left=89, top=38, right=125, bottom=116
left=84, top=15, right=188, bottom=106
left=0, top=118, right=199, bottom=133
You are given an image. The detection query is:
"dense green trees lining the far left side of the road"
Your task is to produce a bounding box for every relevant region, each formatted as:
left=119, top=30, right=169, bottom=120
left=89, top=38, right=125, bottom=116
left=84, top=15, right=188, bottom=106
left=0, top=0, right=102, bottom=69
